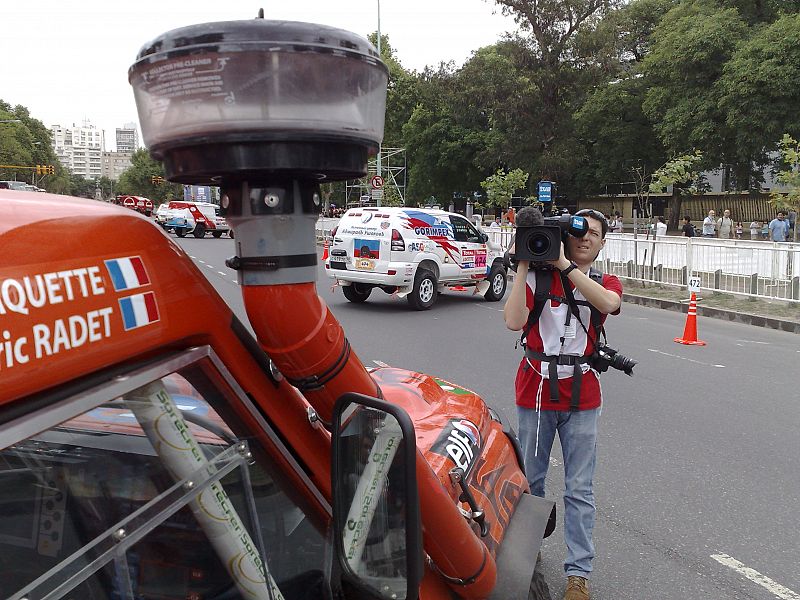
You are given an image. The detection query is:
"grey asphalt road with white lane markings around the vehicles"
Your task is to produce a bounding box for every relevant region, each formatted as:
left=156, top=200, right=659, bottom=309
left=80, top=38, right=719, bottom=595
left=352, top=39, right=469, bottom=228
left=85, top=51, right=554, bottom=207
left=179, top=238, right=800, bottom=600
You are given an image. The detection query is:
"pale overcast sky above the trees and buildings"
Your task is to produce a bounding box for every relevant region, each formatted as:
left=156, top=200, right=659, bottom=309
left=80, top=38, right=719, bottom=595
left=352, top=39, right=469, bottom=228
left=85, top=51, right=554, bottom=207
left=0, top=0, right=516, bottom=150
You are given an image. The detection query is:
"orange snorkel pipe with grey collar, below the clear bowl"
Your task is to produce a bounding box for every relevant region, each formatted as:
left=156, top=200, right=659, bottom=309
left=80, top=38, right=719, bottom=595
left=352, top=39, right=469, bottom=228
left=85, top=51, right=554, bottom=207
left=222, top=178, right=497, bottom=599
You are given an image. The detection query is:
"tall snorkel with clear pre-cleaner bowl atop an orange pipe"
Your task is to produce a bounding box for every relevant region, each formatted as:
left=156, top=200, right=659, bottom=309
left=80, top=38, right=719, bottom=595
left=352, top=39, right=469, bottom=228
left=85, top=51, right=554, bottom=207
left=129, top=19, right=496, bottom=598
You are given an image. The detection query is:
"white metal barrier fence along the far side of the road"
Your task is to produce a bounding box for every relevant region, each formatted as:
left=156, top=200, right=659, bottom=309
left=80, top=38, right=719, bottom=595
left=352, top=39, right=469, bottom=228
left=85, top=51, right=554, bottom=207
left=317, top=219, right=800, bottom=302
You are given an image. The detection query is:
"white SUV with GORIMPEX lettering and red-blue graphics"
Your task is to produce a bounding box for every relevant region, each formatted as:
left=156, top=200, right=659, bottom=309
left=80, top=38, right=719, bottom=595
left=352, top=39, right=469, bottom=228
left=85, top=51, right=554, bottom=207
left=325, top=207, right=506, bottom=310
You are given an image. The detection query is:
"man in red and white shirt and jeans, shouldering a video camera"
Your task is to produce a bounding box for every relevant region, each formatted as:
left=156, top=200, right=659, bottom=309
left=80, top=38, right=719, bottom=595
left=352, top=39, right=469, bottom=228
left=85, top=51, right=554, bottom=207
left=504, top=210, right=622, bottom=600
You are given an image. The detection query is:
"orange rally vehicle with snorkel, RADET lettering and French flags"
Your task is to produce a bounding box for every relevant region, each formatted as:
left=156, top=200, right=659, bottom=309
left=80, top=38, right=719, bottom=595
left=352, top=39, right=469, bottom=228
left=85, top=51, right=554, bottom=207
left=0, top=14, right=553, bottom=600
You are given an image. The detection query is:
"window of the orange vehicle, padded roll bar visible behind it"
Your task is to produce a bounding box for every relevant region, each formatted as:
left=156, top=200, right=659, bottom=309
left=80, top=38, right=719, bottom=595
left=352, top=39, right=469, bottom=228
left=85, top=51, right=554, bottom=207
left=0, top=350, right=324, bottom=600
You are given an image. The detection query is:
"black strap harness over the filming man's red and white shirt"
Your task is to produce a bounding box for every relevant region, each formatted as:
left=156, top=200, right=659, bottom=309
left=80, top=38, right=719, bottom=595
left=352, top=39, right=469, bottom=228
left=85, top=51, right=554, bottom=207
left=520, top=267, right=605, bottom=412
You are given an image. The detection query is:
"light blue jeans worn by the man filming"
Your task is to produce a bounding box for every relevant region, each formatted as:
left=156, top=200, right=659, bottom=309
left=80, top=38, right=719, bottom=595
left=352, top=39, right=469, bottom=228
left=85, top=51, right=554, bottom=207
left=517, top=406, right=600, bottom=577
